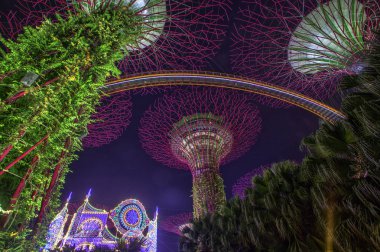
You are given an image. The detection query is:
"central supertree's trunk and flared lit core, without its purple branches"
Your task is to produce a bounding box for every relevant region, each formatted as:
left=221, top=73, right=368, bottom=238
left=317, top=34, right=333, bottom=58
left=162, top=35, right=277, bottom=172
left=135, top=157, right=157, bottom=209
left=169, top=113, right=233, bottom=218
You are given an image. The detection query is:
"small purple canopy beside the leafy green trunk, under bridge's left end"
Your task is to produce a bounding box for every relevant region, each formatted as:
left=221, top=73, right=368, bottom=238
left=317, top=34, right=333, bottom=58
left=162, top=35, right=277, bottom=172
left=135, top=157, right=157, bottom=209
left=82, top=92, right=132, bottom=147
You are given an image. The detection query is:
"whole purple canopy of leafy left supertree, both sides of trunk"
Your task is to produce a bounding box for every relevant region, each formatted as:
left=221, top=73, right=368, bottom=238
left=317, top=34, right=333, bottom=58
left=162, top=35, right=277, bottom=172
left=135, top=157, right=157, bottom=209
left=0, top=0, right=232, bottom=74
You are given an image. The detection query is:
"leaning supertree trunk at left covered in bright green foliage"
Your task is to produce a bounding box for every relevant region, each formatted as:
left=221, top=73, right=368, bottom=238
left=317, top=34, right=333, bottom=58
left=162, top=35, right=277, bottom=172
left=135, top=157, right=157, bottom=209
left=0, top=0, right=172, bottom=234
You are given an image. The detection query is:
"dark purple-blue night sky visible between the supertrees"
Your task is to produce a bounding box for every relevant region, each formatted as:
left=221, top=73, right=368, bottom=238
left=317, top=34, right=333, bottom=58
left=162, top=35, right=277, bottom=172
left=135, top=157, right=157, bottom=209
left=0, top=0, right=318, bottom=252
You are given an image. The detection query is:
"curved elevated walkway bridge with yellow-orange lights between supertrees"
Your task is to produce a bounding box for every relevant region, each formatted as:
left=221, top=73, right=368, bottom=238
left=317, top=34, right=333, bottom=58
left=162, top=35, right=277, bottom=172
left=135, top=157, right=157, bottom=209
left=101, top=71, right=345, bottom=123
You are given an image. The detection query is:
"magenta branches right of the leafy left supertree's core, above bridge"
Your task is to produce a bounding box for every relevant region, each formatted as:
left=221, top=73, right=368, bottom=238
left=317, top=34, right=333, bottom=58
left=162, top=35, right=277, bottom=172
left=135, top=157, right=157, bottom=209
left=119, top=0, right=232, bottom=73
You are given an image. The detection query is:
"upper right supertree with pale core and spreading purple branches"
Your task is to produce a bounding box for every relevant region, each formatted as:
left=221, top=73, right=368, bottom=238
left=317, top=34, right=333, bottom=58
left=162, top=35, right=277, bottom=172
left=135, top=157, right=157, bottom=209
left=232, top=0, right=380, bottom=102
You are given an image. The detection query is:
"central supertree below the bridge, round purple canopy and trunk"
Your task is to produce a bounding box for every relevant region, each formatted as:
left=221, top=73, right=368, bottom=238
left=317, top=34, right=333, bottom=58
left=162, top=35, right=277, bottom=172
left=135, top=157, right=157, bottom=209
left=139, top=88, right=261, bottom=218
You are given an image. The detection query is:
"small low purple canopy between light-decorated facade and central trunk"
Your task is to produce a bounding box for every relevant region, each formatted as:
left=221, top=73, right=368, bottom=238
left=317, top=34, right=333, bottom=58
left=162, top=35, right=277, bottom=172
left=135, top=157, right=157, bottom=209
left=159, top=213, right=193, bottom=236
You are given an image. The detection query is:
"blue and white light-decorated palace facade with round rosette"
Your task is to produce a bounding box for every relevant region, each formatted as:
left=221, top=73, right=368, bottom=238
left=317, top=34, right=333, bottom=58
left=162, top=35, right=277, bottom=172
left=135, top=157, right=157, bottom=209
left=44, top=190, right=158, bottom=252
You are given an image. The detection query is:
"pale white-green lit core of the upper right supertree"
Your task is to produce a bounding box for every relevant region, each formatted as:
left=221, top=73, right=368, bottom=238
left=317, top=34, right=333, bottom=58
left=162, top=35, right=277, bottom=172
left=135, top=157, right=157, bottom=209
left=288, top=0, right=367, bottom=74
